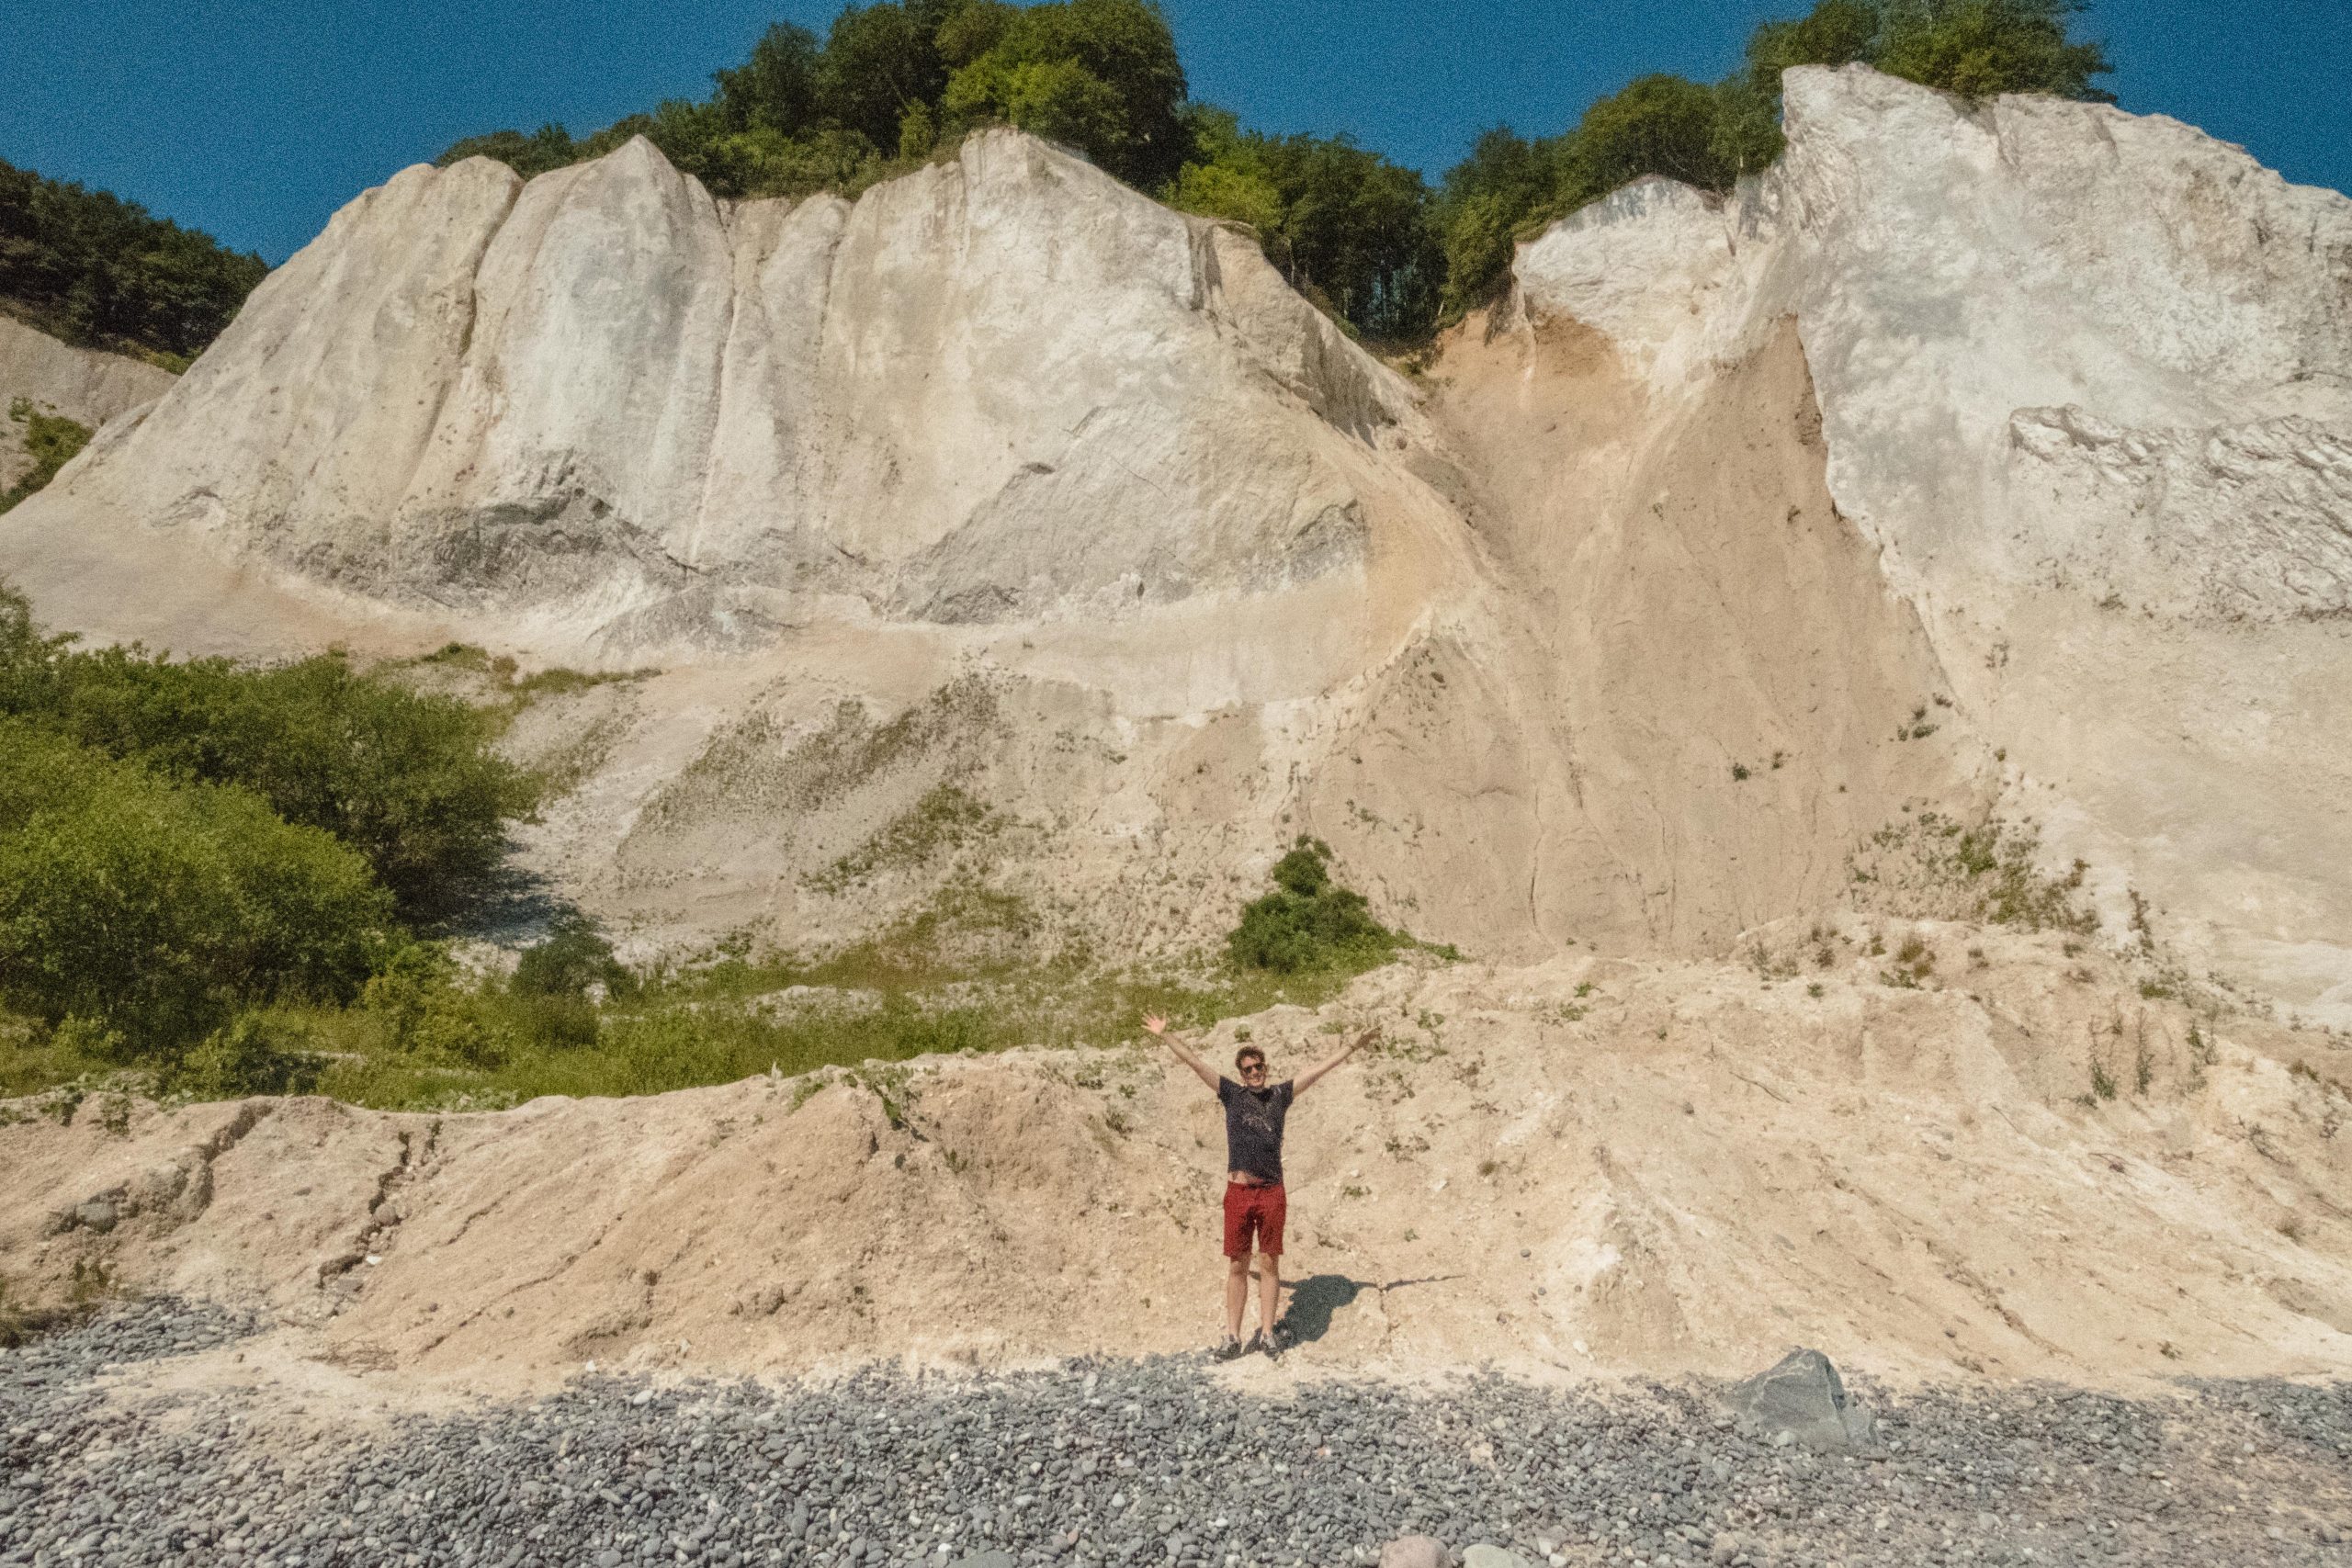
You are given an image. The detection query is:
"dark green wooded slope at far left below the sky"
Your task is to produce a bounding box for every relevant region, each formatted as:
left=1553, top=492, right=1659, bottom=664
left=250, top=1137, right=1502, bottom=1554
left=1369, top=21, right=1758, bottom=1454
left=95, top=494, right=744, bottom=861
left=0, top=160, right=268, bottom=365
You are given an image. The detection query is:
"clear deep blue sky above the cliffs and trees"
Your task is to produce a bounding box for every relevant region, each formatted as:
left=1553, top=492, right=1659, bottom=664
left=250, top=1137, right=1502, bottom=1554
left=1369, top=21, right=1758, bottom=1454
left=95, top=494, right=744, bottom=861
left=0, top=0, right=2352, bottom=261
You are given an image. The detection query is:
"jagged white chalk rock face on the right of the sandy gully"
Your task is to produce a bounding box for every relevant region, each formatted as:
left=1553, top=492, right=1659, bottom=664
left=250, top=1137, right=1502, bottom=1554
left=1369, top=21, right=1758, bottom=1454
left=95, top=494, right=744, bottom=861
left=1517, top=66, right=2352, bottom=1018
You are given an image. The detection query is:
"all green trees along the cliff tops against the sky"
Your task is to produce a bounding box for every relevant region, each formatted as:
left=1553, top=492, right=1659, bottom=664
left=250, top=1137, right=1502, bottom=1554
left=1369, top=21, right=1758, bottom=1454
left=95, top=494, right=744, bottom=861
left=0, top=0, right=2109, bottom=369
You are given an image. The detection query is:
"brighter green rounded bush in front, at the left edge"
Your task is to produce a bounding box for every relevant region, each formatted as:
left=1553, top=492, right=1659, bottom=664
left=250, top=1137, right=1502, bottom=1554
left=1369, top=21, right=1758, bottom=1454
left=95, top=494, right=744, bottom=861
left=0, top=719, right=393, bottom=1058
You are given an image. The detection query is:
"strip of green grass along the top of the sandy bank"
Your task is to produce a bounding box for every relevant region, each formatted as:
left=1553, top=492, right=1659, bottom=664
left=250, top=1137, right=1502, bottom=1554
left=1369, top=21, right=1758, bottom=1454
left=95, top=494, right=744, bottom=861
left=0, top=921, right=1350, bottom=1119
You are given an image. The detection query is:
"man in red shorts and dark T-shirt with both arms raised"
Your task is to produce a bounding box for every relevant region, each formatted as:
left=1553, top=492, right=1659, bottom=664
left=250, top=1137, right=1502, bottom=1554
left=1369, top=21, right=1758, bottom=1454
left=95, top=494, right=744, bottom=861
left=1143, top=1018, right=1378, bottom=1361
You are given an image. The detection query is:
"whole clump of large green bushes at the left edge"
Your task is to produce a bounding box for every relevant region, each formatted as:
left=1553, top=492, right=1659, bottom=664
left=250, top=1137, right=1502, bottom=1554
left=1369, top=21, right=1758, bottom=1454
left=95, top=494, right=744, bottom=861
left=0, top=588, right=537, bottom=1090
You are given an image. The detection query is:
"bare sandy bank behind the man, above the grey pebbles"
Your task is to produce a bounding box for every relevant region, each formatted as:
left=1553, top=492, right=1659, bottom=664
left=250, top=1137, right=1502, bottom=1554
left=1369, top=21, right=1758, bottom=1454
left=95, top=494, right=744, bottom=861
left=0, top=915, right=2352, bottom=1408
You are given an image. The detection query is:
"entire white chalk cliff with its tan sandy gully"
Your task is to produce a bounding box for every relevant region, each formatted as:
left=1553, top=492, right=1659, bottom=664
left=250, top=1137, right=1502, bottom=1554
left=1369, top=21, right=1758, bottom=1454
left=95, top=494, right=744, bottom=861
left=0, top=68, right=2352, bottom=1021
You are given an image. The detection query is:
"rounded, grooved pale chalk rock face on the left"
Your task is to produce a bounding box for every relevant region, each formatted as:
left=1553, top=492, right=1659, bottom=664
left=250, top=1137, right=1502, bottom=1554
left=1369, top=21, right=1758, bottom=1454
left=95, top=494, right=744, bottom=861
left=14, top=131, right=1411, bottom=656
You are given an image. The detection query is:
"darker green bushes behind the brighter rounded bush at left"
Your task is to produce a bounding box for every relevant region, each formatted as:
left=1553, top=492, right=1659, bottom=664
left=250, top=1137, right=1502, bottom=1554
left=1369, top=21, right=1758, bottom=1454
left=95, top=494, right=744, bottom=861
left=0, top=590, right=537, bottom=919
